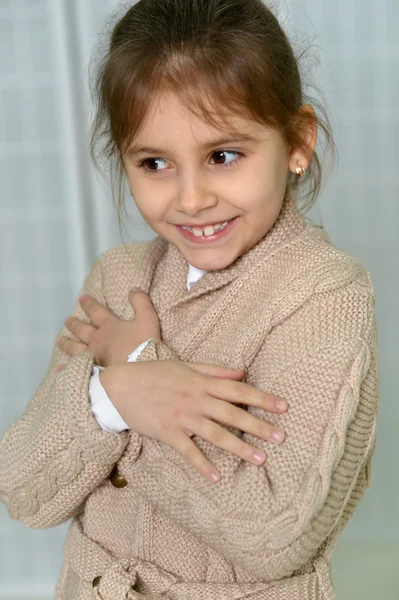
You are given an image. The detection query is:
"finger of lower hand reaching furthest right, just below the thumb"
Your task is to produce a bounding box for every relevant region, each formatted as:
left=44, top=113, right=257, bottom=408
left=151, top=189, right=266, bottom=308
left=207, top=378, right=288, bottom=414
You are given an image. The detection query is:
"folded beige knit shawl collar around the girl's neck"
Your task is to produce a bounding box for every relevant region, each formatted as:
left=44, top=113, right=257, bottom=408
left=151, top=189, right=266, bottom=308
left=140, top=192, right=306, bottom=309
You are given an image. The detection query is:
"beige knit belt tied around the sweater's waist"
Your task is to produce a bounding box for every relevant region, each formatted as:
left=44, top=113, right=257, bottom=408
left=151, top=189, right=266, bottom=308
left=64, top=517, right=333, bottom=600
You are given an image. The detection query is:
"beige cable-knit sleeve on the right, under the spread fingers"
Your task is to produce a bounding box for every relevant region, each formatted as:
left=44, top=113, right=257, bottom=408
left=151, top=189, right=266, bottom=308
left=130, top=281, right=378, bottom=580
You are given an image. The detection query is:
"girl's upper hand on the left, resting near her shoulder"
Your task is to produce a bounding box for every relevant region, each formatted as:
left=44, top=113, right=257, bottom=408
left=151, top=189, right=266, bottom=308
left=56, top=289, right=161, bottom=373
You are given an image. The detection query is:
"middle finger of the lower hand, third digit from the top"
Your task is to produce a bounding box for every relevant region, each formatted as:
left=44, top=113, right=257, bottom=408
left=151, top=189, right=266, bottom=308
left=208, top=399, right=285, bottom=451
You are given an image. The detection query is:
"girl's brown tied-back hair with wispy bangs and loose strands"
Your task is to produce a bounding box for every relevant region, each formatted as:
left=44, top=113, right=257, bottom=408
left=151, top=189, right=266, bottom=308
left=90, top=0, right=336, bottom=230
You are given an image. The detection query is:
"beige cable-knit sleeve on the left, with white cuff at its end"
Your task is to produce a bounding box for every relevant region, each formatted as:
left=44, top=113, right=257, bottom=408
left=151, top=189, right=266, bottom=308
left=0, top=257, right=133, bottom=528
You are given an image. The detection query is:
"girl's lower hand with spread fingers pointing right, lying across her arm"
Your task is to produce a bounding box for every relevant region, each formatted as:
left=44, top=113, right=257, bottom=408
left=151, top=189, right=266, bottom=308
left=100, top=360, right=288, bottom=482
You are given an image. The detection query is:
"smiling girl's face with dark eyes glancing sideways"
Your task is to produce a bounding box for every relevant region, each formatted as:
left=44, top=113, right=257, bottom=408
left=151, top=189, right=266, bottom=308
left=124, top=94, right=308, bottom=271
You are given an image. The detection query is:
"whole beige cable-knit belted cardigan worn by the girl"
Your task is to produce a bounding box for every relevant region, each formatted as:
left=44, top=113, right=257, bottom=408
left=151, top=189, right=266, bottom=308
left=0, top=194, right=379, bottom=600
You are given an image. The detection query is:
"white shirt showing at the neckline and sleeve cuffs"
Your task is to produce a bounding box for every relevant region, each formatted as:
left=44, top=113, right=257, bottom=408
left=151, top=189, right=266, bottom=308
left=89, top=264, right=206, bottom=433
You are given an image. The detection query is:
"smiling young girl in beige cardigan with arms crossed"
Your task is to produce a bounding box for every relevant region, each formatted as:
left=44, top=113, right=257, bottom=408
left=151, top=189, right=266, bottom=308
left=0, top=0, right=378, bottom=600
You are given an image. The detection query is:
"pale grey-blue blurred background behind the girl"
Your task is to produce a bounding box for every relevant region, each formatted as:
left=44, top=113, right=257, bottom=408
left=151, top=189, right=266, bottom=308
left=0, top=0, right=399, bottom=600
